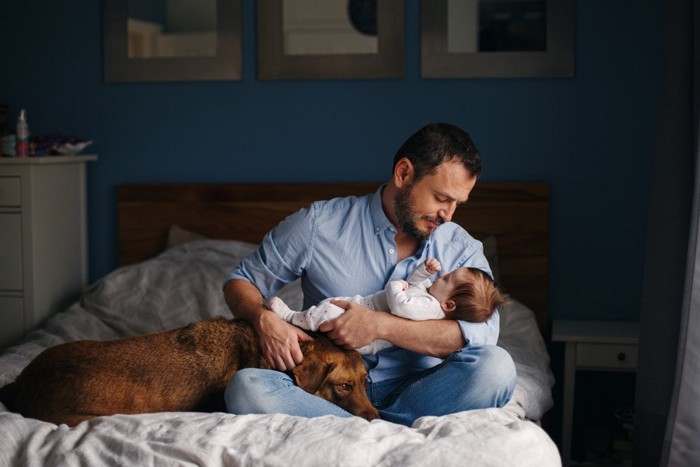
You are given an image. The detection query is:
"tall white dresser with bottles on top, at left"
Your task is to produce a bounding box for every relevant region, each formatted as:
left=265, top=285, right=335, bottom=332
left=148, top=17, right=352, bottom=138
left=0, top=155, right=97, bottom=348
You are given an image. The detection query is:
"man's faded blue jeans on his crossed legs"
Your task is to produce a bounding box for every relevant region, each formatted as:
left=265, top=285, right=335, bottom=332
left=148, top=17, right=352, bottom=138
left=224, top=345, right=515, bottom=426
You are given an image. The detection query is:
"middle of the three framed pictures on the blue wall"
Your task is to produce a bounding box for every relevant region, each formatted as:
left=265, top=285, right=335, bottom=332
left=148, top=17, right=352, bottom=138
left=257, top=0, right=404, bottom=80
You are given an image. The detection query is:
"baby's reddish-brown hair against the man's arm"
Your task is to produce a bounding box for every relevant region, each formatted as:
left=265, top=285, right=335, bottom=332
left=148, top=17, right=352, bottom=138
left=448, top=268, right=508, bottom=323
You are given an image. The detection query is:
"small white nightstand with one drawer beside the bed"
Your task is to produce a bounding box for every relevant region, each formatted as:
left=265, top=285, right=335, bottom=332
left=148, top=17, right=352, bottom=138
left=552, top=320, right=639, bottom=465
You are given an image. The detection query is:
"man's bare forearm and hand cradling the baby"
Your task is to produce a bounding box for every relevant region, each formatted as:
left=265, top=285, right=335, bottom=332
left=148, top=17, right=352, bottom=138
left=319, top=300, right=466, bottom=358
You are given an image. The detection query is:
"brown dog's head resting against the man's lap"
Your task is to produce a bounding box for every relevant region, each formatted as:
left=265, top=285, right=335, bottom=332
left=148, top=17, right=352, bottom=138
left=292, top=337, right=379, bottom=420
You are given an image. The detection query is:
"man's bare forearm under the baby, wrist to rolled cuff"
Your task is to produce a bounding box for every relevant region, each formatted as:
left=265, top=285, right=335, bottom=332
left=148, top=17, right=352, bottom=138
left=376, top=313, right=466, bottom=358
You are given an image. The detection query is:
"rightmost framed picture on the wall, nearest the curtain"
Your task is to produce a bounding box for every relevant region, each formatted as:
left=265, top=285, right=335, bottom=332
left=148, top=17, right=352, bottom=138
left=421, top=0, right=574, bottom=78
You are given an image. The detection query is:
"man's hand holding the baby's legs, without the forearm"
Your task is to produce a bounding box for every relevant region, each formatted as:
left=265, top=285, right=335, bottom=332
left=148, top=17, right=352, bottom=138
left=319, top=300, right=387, bottom=349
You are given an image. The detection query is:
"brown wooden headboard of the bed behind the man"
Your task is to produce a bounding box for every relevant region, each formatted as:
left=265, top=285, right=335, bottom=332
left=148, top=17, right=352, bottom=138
left=118, top=182, right=549, bottom=335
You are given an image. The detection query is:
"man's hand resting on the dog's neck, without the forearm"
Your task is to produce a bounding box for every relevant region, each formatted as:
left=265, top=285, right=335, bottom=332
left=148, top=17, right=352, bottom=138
left=255, top=312, right=313, bottom=371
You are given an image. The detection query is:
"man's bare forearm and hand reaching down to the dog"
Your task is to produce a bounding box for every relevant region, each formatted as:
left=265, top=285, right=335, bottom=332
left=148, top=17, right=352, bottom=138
left=224, top=279, right=312, bottom=371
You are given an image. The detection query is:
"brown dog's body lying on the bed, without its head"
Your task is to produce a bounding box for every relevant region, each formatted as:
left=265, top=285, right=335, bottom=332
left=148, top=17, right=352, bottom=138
left=9, top=318, right=267, bottom=425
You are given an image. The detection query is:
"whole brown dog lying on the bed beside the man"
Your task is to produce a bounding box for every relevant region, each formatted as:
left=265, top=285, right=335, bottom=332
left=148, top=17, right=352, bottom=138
left=0, top=317, right=379, bottom=426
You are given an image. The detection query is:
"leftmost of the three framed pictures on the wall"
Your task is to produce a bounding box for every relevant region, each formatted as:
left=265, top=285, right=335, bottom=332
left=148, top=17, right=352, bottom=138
left=102, top=0, right=241, bottom=82
